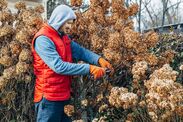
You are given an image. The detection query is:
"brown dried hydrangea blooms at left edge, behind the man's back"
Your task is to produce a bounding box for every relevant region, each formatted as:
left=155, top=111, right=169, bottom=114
left=0, top=0, right=44, bottom=105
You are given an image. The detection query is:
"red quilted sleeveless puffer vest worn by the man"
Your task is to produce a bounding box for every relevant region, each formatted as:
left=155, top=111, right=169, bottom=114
left=32, top=24, right=72, bottom=102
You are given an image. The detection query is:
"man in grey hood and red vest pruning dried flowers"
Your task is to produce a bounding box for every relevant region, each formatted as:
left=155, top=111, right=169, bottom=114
left=32, top=5, right=113, bottom=122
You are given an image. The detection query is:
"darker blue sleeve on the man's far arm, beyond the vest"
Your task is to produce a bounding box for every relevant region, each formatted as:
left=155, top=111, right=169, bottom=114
left=71, top=41, right=101, bottom=65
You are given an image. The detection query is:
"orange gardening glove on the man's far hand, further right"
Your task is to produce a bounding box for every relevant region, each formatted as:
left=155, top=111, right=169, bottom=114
left=98, top=58, right=114, bottom=75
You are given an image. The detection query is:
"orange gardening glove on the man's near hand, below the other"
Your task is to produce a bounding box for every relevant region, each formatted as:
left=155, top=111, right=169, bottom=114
left=90, top=65, right=105, bottom=80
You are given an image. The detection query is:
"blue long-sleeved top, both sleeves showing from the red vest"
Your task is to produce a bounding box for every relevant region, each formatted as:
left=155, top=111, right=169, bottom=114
left=34, top=36, right=100, bottom=75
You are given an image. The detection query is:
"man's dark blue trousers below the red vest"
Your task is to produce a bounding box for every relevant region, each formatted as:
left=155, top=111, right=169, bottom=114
left=35, top=98, right=72, bottom=122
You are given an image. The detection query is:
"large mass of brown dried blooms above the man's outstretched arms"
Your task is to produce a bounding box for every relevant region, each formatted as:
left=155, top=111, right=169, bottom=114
left=71, top=0, right=162, bottom=66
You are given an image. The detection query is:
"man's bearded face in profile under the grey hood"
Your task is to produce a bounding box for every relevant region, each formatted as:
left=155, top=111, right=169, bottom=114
left=60, top=20, right=74, bottom=34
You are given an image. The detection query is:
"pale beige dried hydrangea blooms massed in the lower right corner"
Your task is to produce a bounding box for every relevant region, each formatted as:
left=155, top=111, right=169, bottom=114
left=144, top=64, right=183, bottom=121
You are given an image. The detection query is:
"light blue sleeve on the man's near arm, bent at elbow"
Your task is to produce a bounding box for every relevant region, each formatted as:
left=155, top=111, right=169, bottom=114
left=34, top=36, right=89, bottom=75
